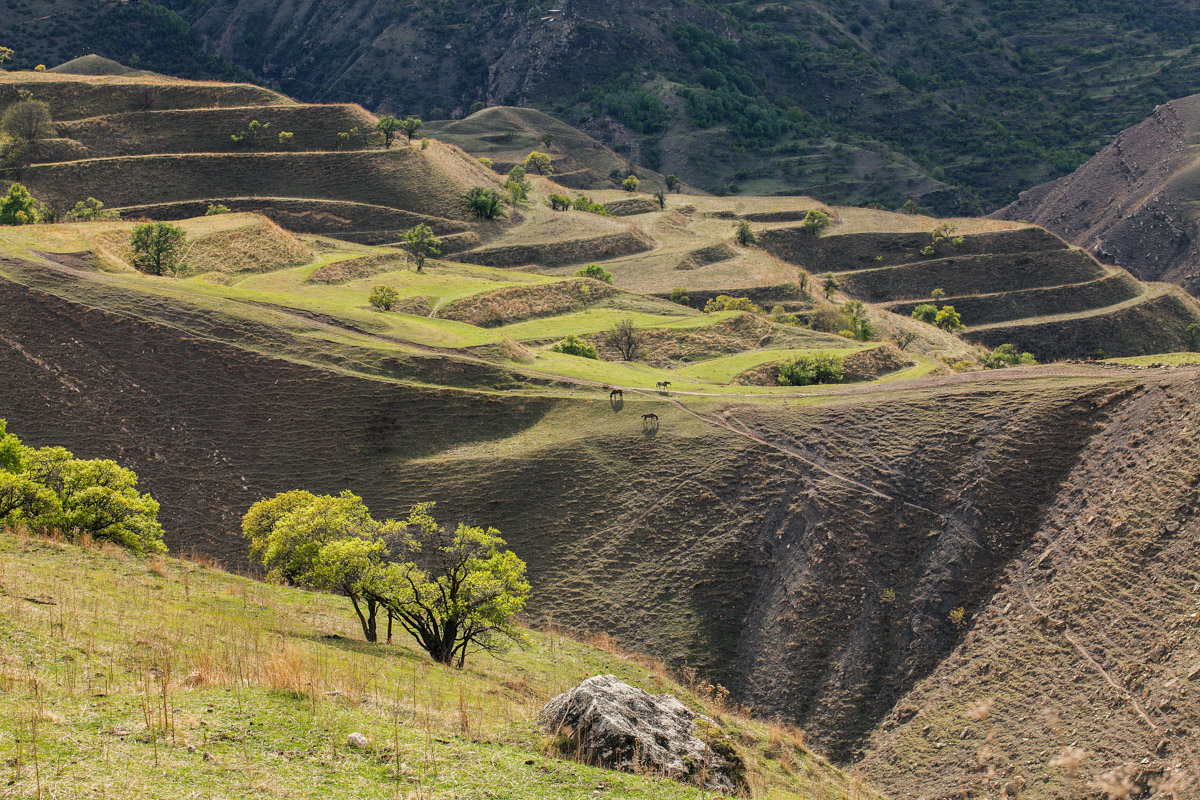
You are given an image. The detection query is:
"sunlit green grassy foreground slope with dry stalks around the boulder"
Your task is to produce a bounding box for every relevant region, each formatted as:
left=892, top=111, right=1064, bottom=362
left=0, top=533, right=876, bottom=800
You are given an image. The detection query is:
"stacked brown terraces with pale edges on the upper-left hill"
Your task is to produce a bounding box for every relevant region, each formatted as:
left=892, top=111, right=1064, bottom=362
left=0, top=70, right=497, bottom=242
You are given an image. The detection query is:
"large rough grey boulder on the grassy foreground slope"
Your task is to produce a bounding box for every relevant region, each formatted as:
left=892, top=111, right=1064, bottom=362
left=539, top=675, right=738, bottom=792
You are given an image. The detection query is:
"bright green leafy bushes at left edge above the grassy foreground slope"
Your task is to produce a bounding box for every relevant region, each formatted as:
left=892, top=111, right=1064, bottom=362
left=0, top=420, right=167, bottom=553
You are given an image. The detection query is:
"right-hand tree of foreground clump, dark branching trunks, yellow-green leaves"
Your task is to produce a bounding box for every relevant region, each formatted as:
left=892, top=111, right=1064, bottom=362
left=386, top=503, right=529, bottom=668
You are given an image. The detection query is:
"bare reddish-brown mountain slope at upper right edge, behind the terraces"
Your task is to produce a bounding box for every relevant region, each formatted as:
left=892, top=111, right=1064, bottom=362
left=995, top=95, right=1200, bottom=294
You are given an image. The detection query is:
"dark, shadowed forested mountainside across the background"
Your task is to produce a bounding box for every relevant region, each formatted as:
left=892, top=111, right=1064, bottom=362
left=7, top=0, right=1200, bottom=213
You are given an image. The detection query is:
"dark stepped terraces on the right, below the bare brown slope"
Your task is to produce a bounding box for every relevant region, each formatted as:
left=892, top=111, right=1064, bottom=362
left=761, top=217, right=1200, bottom=360
